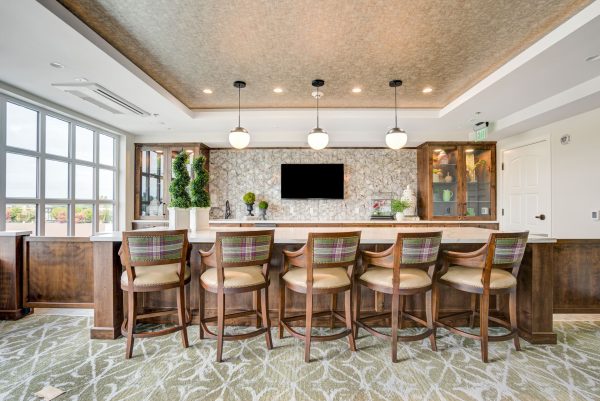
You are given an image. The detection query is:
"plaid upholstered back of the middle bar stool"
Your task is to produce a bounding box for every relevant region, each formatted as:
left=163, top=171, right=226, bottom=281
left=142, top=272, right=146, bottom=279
left=308, top=231, right=360, bottom=267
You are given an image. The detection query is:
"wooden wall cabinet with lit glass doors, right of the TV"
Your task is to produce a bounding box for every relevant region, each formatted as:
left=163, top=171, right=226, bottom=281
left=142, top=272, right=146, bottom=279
left=417, top=142, right=496, bottom=221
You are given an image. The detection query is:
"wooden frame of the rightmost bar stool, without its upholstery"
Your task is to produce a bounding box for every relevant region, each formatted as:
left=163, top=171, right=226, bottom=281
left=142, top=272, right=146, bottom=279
left=433, top=231, right=529, bottom=363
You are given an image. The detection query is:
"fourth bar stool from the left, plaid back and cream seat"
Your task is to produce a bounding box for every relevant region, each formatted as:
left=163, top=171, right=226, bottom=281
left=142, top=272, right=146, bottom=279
left=354, top=231, right=442, bottom=362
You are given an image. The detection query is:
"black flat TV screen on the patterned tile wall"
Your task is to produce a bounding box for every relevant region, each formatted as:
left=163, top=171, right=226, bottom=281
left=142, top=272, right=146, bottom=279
left=281, top=164, right=344, bottom=199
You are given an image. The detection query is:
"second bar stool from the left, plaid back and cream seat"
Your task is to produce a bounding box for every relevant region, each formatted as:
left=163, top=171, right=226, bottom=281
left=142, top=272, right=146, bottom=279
left=199, top=230, right=275, bottom=362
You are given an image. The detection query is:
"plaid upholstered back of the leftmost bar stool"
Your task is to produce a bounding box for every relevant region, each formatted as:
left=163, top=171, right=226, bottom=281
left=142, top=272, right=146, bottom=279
left=122, top=230, right=188, bottom=266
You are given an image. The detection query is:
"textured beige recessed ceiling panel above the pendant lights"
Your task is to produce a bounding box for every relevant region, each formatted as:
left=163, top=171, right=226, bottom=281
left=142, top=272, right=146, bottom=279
left=59, top=0, right=591, bottom=109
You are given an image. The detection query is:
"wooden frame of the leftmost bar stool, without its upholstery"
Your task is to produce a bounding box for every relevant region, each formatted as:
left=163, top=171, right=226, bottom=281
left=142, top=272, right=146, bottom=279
left=119, top=230, right=191, bottom=359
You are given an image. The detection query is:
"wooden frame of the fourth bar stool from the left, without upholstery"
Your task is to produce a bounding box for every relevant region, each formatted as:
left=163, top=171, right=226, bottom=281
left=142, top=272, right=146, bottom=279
left=354, top=231, right=442, bottom=362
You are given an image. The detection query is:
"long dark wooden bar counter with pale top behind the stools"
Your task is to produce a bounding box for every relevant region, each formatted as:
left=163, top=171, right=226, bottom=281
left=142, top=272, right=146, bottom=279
left=90, top=226, right=556, bottom=344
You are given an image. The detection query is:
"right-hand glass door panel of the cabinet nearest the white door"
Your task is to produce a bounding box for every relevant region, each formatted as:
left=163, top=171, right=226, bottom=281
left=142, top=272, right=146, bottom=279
left=464, top=147, right=492, bottom=217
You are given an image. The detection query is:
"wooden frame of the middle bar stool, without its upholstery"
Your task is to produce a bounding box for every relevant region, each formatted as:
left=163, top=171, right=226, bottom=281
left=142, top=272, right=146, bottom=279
left=278, top=231, right=361, bottom=362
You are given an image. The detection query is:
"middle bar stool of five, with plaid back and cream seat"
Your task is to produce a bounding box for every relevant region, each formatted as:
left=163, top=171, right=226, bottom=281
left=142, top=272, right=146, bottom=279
left=279, top=231, right=360, bottom=362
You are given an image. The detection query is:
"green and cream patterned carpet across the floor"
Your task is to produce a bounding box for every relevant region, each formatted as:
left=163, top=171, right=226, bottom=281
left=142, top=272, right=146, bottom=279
left=0, top=315, right=600, bottom=401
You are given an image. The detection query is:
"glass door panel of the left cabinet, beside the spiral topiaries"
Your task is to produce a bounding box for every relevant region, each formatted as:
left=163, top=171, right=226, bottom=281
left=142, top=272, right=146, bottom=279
left=140, top=149, right=164, bottom=218
